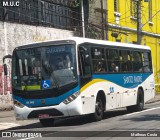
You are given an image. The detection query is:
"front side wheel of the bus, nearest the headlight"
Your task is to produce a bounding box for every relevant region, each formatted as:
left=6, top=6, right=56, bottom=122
left=93, top=97, right=104, bottom=121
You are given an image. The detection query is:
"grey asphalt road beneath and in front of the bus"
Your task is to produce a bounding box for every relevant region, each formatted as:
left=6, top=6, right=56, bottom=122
left=0, top=102, right=160, bottom=140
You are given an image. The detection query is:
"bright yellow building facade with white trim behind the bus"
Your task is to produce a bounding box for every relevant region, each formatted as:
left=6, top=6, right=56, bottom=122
left=107, top=0, right=160, bottom=91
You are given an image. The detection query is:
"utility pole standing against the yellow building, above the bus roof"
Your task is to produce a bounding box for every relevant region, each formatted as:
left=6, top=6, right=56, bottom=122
left=137, top=0, right=142, bottom=45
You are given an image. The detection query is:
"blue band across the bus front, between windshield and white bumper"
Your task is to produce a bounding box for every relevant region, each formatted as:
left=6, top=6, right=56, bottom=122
left=12, top=86, right=80, bottom=107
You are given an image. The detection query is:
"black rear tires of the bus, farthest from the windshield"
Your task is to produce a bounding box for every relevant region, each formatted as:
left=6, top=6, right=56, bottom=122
left=127, top=88, right=144, bottom=112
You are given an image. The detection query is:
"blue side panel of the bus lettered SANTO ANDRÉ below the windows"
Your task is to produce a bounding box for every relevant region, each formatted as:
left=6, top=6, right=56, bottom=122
left=92, top=73, right=153, bottom=88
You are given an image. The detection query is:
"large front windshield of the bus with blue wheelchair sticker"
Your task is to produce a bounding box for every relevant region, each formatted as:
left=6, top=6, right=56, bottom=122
left=12, top=44, right=77, bottom=90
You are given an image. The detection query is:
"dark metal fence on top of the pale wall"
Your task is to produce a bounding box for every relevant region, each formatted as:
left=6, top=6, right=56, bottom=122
left=0, top=0, right=81, bottom=30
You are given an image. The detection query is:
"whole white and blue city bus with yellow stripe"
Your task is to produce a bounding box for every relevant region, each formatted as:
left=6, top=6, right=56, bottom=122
left=9, top=37, right=155, bottom=126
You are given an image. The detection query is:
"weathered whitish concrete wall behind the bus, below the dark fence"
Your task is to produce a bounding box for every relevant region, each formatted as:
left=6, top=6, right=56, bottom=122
left=0, top=22, right=73, bottom=110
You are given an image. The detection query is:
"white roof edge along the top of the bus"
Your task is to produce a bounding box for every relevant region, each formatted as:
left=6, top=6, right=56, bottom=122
left=16, top=37, right=150, bottom=50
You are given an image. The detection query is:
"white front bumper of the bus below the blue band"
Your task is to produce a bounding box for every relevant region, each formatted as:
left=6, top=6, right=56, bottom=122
left=14, top=96, right=83, bottom=120
